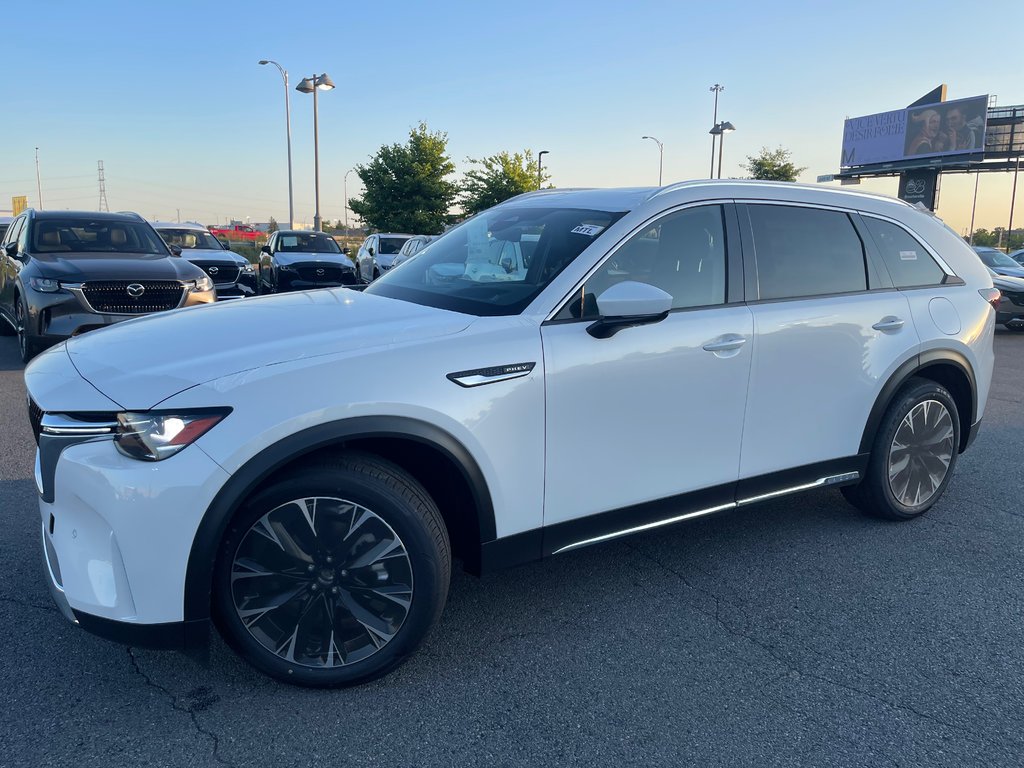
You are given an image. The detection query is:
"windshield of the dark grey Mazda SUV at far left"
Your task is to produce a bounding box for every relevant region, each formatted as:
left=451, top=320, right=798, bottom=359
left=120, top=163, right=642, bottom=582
left=32, top=217, right=168, bottom=256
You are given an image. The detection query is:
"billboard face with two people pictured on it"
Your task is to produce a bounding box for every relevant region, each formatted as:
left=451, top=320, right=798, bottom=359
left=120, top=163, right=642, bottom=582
left=840, top=96, right=988, bottom=168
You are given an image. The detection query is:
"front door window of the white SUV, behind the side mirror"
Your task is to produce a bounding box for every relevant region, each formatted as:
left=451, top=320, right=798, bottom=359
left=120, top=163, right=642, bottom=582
left=558, top=206, right=726, bottom=319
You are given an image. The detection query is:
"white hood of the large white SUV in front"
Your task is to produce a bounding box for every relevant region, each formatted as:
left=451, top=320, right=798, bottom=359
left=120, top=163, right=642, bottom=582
left=67, top=289, right=473, bottom=410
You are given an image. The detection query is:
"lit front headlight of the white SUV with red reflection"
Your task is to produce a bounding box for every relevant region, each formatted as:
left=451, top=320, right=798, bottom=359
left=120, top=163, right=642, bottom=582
left=114, top=409, right=230, bottom=462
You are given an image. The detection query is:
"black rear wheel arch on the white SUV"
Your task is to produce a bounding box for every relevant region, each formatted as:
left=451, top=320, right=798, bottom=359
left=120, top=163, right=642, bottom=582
left=860, top=349, right=978, bottom=454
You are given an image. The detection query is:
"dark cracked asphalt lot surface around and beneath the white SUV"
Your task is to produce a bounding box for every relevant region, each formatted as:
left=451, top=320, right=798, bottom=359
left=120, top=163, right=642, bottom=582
left=0, top=330, right=1024, bottom=768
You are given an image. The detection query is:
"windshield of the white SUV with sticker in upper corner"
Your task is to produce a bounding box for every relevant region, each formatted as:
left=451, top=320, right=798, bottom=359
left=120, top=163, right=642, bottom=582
left=366, top=208, right=625, bottom=315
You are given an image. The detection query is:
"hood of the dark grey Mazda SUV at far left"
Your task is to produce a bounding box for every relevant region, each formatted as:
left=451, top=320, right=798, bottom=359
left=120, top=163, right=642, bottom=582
left=31, top=253, right=203, bottom=283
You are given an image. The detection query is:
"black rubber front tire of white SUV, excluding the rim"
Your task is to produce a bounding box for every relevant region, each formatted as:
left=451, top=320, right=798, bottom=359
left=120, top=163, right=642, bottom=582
left=213, top=467, right=449, bottom=687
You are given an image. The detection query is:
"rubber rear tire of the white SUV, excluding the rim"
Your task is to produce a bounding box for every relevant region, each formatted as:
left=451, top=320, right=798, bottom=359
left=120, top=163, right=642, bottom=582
left=871, top=380, right=961, bottom=519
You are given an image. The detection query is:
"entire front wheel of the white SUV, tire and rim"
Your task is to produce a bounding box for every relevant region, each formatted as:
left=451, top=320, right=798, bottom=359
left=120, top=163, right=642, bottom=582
left=213, top=453, right=452, bottom=688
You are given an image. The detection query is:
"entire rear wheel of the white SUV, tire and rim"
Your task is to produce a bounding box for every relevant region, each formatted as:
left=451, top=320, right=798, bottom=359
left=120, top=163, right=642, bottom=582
left=842, top=378, right=961, bottom=520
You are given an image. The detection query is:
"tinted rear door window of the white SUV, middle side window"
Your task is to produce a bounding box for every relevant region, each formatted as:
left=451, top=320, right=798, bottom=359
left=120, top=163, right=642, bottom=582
left=748, top=205, right=867, bottom=299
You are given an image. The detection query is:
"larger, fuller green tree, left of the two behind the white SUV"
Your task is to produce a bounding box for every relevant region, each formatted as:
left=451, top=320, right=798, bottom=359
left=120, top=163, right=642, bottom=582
left=348, top=123, right=459, bottom=234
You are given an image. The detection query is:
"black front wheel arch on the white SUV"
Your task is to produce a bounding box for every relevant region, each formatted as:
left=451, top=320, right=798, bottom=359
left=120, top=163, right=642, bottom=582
left=183, top=416, right=497, bottom=621
